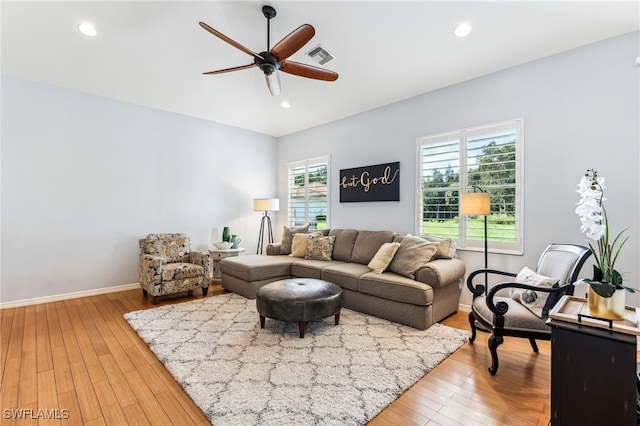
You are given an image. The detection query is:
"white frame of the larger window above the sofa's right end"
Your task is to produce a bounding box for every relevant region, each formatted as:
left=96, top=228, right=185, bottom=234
left=415, top=117, right=525, bottom=255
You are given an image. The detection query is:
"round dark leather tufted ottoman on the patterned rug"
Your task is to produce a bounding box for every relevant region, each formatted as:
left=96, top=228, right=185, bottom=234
left=256, top=278, right=342, bottom=338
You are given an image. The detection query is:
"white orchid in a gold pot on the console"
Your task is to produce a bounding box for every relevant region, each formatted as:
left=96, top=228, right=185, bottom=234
left=575, top=169, right=634, bottom=320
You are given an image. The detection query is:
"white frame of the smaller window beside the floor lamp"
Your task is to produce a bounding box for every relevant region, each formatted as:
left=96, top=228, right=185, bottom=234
left=285, top=155, right=331, bottom=230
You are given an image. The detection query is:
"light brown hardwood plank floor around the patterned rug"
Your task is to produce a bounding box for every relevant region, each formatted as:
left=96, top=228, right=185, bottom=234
left=0, top=285, right=550, bottom=426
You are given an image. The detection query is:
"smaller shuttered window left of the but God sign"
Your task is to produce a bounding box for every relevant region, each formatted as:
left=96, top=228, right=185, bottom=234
left=287, top=156, right=329, bottom=230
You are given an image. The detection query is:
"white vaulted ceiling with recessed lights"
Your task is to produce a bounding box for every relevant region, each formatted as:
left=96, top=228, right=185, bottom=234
left=1, top=0, right=640, bottom=136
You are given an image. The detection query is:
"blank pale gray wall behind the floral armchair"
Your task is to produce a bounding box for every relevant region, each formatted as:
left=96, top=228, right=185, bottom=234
left=0, top=76, right=277, bottom=303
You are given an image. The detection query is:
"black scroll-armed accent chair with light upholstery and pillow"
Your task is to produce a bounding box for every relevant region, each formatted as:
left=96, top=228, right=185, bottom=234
left=467, top=244, right=591, bottom=375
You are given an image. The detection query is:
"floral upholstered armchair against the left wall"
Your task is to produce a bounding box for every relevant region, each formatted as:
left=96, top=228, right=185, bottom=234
left=139, top=234, right=210, bottom=304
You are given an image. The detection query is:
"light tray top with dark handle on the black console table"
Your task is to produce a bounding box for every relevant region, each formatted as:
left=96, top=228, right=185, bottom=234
left=549, top=296, right=640, bottom=336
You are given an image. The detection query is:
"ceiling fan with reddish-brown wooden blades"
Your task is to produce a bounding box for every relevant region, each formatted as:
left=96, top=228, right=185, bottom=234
left=200, top=6, right=338, bottom=96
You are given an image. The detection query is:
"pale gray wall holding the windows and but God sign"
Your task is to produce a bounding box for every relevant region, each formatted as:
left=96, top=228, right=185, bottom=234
left=278, top=32, right=640, bottom=305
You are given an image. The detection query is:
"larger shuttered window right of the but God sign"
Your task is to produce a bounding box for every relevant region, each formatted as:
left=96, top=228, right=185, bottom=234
left=416, top=119, right=523, bottom=254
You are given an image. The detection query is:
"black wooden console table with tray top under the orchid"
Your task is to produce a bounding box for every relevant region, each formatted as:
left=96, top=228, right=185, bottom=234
left=547, top=296, right=640, bottom=426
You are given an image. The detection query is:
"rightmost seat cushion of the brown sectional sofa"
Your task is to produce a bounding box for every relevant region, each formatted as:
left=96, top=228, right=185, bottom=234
left=358, top=272, right=433, bottom=306
